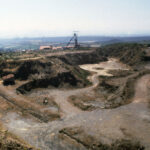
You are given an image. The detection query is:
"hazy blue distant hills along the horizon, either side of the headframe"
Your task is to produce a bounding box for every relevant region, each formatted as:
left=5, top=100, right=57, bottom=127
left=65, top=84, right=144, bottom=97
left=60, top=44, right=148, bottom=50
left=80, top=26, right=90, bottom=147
left=0, top=36, right=150, bottom=50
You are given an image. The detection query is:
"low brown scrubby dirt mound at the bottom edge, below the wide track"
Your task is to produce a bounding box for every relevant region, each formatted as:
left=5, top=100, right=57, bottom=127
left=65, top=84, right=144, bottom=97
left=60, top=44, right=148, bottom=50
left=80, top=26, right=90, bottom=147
left=59, top=127, right=145, bottom=150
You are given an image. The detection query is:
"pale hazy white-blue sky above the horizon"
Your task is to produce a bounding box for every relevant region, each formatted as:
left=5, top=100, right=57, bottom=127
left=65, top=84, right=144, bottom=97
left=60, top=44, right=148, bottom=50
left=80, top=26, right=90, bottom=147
left=0, top=0, right=150, bottom=37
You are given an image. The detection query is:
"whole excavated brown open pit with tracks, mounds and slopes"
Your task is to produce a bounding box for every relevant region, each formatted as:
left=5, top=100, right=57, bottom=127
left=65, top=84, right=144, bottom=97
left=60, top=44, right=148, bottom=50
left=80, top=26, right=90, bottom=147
left=0, top=43, right=150, bottom=150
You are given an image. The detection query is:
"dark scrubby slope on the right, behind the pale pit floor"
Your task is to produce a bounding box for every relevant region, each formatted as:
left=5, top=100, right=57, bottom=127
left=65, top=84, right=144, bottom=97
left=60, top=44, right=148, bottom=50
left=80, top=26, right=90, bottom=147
left=97, top=43, right=147, bottom=67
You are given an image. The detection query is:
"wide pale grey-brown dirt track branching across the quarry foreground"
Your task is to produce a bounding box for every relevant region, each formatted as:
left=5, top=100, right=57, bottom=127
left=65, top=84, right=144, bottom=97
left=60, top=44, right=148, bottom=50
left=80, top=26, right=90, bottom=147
left=0, top=59, right=150, bottom=150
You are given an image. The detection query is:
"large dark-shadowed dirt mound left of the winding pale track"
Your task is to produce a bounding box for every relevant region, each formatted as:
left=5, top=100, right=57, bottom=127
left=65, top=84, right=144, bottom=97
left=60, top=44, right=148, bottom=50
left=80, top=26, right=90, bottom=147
left=15, top=58, right=90, bottom=94
